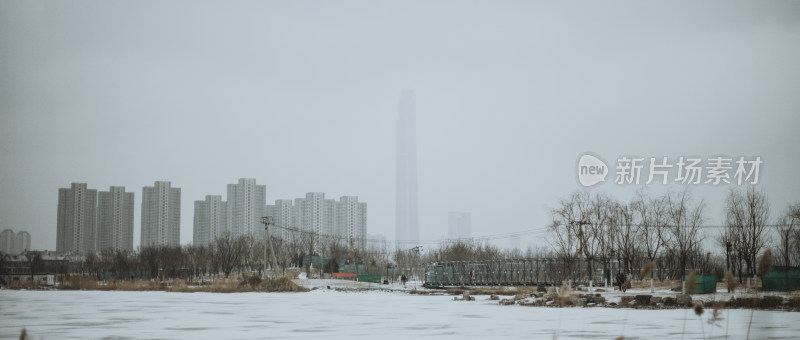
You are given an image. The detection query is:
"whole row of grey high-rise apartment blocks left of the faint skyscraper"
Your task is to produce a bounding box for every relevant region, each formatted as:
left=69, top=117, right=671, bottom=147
left=41, top=178, right=376, bottom=254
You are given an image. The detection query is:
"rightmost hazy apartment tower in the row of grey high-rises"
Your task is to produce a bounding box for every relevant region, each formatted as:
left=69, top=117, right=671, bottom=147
left=336, top=196, right=367, bottom=249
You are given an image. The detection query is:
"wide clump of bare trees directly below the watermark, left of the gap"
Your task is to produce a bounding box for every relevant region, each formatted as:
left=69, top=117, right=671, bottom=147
left=549, top=192, right=705, bottom=278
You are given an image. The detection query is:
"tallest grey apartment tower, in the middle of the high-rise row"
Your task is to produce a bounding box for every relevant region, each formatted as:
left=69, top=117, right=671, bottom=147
left=228, top=178, right=267, bottom=239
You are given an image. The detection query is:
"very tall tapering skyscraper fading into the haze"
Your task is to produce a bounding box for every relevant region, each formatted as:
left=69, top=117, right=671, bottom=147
left=395, top=91, right=419, bottom=249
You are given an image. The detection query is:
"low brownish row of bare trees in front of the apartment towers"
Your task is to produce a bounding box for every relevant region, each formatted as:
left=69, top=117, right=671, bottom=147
left=72, top=232, right=396, bottom=279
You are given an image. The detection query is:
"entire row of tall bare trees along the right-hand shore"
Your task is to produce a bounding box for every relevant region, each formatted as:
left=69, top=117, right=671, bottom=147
left=549, top=187, right=800, bottom=279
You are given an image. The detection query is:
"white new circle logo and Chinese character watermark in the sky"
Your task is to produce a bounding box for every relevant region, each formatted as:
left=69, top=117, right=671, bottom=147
left=578, top=154, right=764, bottom=187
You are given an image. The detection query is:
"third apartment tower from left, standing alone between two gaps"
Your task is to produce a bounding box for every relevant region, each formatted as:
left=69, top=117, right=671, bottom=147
left=142, top=181, right=181, bottom=247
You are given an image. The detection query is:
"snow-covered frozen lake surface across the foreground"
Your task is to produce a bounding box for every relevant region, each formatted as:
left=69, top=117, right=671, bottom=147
left=0, top=290, right=800, bottom=339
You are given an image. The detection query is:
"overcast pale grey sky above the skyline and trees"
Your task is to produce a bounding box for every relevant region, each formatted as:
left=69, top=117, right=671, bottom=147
left=0, top=0, right=800, bottom=249
